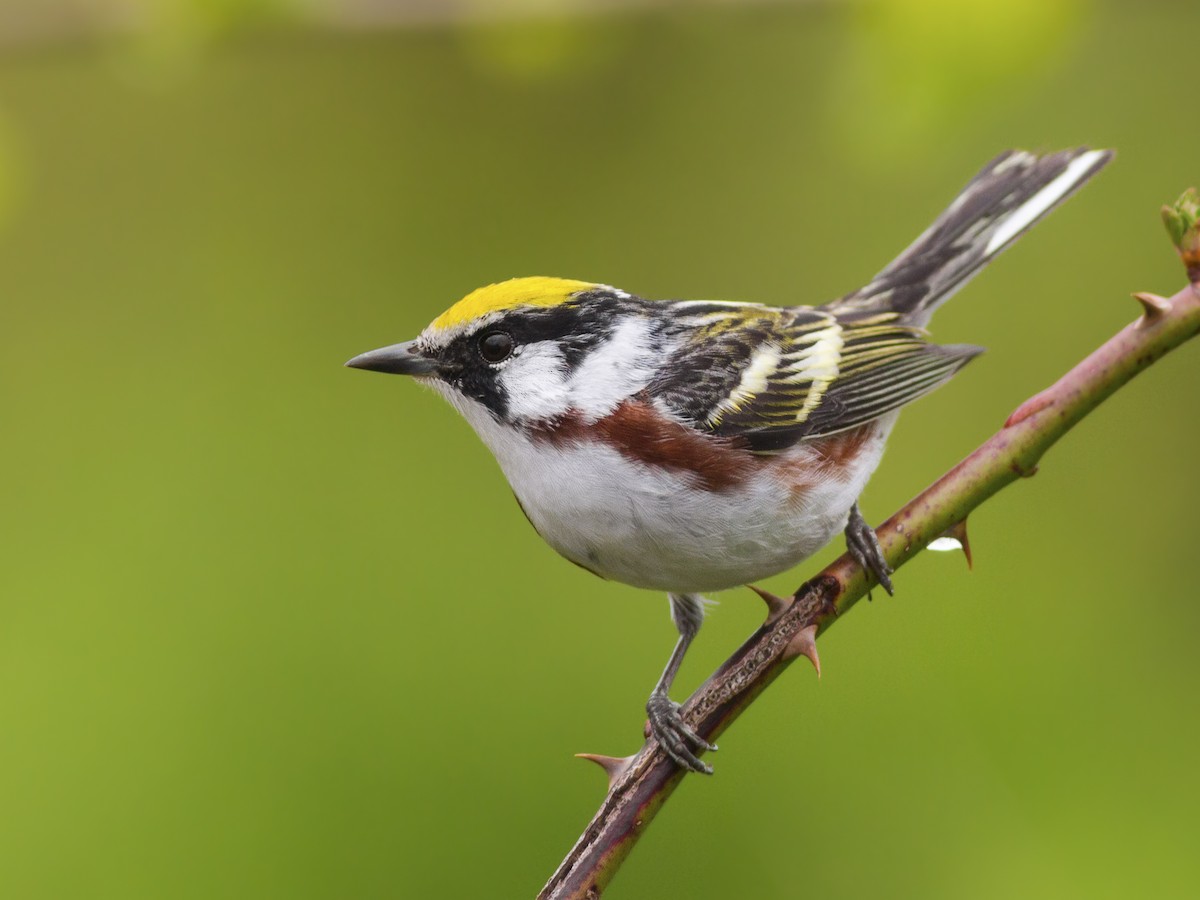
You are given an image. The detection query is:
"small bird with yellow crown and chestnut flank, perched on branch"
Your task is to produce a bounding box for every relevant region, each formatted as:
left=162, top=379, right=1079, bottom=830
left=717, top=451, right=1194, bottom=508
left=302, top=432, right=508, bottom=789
left=346, top=148, right=1112, bottom=774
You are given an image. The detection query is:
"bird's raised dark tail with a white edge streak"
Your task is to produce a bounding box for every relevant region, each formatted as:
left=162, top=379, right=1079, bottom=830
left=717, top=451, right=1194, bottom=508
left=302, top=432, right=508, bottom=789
left=829, top=148, right=1112, bottom=325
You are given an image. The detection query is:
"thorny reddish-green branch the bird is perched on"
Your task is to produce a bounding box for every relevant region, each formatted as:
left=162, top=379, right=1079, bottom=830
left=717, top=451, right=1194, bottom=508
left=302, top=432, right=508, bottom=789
left=538, top=191, right=1200, bottom=900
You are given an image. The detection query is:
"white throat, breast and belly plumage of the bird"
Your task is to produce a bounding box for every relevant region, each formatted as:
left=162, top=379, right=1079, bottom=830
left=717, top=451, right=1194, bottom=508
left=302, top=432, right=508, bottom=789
left=448, top=392, right=895, bottom=593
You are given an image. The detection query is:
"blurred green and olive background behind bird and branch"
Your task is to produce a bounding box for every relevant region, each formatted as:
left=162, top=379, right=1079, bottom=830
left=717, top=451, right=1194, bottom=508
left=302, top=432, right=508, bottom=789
left=0, top=0, right=1200, bottom=900
